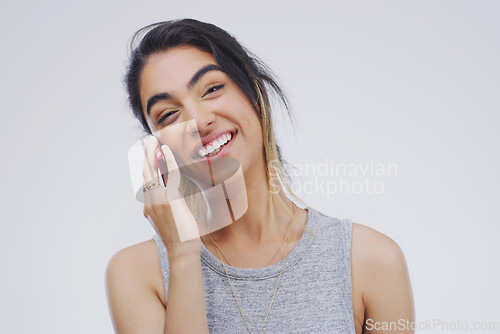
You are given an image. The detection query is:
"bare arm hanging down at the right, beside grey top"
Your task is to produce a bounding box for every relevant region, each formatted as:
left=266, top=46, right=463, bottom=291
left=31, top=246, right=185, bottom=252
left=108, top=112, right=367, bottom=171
left=352, top=224, right=415, bottom=334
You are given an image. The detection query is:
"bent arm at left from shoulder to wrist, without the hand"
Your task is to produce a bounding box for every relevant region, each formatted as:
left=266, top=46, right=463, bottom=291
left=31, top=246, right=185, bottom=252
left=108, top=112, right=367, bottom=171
left=106, top=241, right=208, bottom=334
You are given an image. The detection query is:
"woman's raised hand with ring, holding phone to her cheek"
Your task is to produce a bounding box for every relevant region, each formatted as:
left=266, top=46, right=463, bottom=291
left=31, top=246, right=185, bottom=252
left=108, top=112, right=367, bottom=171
left=143, top=136, right=201, bottom=259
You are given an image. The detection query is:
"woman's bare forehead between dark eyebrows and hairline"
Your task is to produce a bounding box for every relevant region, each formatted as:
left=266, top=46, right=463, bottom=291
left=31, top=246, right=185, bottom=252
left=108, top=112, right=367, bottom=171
left=140, top=46, right=217, bottom=99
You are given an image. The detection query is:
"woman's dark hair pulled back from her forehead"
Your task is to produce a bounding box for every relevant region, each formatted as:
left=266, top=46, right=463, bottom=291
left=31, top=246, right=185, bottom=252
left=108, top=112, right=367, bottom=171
left=125, top=19, right=289, bottom=134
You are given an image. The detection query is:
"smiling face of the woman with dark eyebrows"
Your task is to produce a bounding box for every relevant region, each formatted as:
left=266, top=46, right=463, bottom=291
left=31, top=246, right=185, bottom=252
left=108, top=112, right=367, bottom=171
left=140, top=46, right=264, bottom=183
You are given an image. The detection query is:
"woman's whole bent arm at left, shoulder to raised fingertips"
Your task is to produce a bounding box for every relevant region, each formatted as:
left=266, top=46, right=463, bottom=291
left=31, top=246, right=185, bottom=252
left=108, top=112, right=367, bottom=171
left=106, top=140, right=208, bottom=334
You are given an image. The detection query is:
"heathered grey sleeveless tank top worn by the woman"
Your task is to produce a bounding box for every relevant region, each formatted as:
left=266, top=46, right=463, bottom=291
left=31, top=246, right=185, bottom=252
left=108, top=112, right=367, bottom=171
left=153, top=208, right=355, bottom=334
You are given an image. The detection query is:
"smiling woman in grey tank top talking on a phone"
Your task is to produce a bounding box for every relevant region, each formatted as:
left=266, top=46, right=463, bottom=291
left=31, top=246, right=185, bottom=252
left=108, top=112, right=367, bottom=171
left=107, top=19, right=414, bottom=333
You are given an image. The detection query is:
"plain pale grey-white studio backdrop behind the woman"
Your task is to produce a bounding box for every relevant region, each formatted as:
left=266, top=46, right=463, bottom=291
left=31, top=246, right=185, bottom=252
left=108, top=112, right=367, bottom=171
left=0, top=0, right=500, bottom=334
